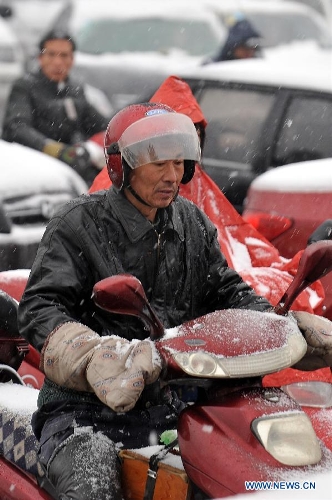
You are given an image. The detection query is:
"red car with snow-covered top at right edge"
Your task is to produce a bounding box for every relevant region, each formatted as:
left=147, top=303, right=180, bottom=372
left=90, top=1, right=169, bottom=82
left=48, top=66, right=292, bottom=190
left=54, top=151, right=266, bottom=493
left=243, top=158, right=332, bottom=319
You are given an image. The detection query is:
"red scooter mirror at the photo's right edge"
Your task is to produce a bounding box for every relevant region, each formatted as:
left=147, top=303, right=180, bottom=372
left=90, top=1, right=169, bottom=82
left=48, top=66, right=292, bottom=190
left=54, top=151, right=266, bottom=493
left=275, top=240, right=332, bottom=314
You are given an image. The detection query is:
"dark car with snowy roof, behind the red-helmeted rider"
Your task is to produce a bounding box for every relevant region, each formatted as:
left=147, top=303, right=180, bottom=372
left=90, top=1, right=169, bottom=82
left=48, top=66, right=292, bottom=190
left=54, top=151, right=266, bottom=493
left=167, top=49, right=332, bottom=213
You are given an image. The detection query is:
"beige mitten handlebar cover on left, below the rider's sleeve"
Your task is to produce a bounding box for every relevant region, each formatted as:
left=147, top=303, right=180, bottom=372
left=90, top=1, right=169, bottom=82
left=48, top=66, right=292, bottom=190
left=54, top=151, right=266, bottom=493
left=41, top=322, right=162, bottom=412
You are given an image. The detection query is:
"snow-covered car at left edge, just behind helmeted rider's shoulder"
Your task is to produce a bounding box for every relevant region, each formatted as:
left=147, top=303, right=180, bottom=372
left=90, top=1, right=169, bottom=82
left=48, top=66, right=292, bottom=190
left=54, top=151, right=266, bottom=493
left=0, top=140, right=87, bottom=271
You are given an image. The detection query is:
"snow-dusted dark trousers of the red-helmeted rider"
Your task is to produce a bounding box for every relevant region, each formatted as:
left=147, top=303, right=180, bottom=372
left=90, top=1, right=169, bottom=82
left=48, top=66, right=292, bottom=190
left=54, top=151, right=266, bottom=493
left=32, top=394, right=184, bottom=500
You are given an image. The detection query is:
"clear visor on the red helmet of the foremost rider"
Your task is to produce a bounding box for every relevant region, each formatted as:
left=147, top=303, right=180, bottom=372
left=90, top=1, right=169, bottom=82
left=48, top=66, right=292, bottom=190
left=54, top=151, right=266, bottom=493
left=118, top=113, right=201, bottom=169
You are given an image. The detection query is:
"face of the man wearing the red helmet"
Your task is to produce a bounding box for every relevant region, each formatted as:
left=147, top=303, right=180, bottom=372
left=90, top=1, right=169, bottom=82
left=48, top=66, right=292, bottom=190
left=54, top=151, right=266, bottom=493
left=126, top=159, right=184, bottom=220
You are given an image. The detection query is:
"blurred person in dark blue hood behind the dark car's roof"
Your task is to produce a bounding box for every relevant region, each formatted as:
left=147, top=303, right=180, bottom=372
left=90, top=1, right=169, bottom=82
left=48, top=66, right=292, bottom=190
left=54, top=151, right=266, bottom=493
left=203, top=14, right=261, bottom=64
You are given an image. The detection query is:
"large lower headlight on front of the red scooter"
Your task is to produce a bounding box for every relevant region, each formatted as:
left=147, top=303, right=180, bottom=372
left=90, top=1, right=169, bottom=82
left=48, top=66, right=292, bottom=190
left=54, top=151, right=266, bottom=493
left=252, top=412, right=322, bottom=466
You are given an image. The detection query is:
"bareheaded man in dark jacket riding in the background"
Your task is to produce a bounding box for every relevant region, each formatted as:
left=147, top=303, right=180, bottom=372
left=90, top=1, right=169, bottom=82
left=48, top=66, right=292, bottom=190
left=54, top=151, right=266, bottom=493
left=2, top=30, right=109, bottom=185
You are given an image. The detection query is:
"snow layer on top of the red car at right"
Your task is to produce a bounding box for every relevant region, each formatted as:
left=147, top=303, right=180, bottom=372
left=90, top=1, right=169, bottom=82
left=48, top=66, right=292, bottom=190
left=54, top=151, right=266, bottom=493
left=251, top=158, right=332, bottom=193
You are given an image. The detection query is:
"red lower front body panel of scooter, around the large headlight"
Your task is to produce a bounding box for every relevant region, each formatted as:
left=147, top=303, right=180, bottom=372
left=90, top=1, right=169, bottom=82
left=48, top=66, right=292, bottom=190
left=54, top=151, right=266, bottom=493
left=178, top=388, right=332, bottom=498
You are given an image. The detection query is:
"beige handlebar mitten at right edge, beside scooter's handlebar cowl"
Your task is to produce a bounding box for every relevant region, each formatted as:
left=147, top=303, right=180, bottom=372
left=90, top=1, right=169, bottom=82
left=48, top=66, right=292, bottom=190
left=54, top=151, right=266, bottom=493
left=292, top=311, right=332, bottom=370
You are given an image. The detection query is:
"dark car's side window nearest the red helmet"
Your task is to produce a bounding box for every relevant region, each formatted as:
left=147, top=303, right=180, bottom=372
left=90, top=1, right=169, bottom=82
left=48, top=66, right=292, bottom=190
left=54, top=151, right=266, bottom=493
left=199, top=88, right=275, bottom=164
